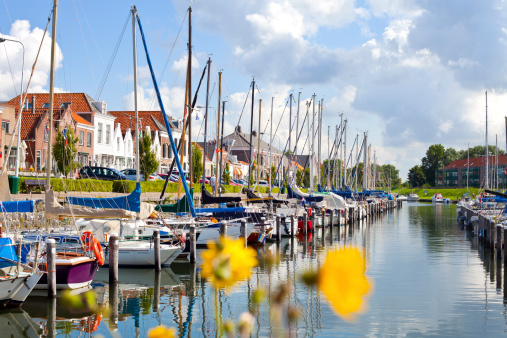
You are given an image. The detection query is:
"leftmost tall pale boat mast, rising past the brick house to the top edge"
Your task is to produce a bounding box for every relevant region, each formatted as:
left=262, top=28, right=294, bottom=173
left=45, top=0, right=58, bottom=192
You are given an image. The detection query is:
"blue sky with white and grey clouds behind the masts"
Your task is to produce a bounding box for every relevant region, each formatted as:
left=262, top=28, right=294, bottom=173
left=0, top=0, right=507, bottom=179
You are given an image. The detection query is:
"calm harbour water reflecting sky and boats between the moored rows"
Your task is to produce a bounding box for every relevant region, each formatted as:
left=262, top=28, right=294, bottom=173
left=0, top=204, right=507, bottom=337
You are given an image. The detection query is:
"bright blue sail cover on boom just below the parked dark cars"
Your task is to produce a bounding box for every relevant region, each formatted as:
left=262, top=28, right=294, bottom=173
left=67, top=182, right=141, bottom=212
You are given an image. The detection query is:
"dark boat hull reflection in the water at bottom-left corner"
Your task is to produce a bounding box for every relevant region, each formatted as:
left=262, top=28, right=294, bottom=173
left=0, top=310, right=43, bottom=337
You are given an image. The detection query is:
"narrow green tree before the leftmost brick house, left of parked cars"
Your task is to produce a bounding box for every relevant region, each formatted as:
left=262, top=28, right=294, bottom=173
left=53, top=128, right=79, bottom=176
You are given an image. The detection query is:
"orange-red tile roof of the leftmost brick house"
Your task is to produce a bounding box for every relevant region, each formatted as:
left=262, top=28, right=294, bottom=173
left=7, top=93, right=97, bottom=113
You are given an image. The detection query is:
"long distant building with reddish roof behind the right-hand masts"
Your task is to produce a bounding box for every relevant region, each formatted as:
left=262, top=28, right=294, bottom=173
left=435, top=155, right=507, bottom=188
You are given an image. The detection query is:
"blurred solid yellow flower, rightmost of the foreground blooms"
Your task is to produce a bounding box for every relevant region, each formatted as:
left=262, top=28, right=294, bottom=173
left=317, top=247, right=372, bottom=320
